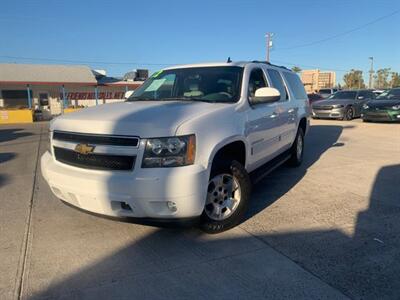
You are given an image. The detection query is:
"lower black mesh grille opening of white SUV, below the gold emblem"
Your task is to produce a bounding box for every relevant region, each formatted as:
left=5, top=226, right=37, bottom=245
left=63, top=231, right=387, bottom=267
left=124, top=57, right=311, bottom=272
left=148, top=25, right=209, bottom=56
left=54, top=147, right=136, bottom=171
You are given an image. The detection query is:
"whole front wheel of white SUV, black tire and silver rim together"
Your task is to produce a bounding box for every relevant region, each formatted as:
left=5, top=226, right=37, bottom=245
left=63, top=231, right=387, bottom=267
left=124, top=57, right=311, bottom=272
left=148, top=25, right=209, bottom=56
left=200, top=160, right=251, bottom=234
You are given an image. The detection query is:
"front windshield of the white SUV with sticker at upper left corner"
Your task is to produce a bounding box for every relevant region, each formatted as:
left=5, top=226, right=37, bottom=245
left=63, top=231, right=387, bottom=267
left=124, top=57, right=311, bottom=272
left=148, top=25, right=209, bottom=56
left=127, top=67, right=243, bottom=103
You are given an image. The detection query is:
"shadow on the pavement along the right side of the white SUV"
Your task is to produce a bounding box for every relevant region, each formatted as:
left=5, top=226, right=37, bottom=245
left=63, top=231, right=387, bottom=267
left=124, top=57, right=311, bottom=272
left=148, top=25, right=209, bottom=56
left=246, top=125, right=346, bottom=220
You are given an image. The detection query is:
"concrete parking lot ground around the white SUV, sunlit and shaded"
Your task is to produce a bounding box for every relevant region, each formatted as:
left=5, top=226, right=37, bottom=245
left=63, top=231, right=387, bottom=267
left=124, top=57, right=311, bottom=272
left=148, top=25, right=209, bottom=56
left=0, top=120, right=400, bottom=299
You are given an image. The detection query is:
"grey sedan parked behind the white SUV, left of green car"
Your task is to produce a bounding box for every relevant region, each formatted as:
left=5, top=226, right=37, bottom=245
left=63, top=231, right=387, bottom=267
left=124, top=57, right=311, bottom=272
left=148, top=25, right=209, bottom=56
left=312, top=90, right=375, bottom=120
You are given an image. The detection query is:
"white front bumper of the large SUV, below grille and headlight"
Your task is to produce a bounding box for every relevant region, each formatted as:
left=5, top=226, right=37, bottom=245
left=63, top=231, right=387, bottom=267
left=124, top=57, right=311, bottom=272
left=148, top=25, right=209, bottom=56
left=41, top=152, right=209, bottom=219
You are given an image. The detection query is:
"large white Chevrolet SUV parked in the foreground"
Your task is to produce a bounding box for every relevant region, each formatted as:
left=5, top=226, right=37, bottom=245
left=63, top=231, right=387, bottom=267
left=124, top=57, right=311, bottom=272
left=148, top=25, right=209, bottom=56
left=41, top=61, right=309, bottom=232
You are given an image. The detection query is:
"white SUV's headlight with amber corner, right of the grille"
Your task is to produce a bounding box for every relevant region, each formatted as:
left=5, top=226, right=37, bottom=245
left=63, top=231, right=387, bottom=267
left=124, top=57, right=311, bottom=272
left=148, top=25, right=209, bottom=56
left=142, top=135, right=196, bottom=168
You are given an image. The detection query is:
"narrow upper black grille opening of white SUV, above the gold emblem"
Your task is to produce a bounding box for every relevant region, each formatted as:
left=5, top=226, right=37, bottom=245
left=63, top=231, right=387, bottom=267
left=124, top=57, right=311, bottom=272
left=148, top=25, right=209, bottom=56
left=53, top=131, right=139, bottom=147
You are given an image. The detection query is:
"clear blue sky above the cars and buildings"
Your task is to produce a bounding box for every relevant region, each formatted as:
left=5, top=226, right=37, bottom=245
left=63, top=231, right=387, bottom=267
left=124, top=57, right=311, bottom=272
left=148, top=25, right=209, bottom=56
left=0, top=0, right=400, bottom=82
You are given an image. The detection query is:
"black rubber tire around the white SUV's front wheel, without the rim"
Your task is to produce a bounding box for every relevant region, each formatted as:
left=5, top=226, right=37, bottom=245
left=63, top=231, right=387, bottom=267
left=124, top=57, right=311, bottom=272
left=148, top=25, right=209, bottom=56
left=200, top=160, right=251, bottom=234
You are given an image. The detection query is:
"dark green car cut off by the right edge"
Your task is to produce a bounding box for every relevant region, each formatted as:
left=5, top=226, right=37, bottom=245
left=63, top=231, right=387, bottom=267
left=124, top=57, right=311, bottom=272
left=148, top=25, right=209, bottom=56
left=361, top=88, right=400, bottom=122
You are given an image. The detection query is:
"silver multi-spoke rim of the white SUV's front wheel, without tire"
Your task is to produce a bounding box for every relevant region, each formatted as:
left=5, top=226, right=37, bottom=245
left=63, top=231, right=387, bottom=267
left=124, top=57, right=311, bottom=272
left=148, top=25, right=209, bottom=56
left=204, top=174, right=241, bottom=221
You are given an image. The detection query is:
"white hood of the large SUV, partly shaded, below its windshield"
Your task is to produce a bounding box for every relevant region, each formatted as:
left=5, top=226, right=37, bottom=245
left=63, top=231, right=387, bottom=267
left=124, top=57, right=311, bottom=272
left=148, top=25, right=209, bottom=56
left=50, top=101, right=227, bottom=137
